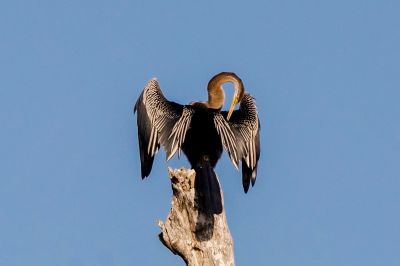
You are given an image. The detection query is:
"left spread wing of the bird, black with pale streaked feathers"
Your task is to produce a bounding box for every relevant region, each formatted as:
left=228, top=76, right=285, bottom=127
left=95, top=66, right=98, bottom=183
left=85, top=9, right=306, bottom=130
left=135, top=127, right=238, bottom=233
left=134, top=78, right=193, bottom=178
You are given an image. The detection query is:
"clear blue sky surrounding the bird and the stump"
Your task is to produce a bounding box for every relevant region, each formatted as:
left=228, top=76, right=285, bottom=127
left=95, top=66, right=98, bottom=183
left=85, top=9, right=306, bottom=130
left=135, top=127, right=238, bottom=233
left=0, top=0, right=400, bottom=266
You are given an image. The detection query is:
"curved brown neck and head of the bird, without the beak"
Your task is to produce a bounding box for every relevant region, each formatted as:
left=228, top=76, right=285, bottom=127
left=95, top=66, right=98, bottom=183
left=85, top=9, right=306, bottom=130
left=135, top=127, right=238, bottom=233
left=206, top=72, right=244, bottom=109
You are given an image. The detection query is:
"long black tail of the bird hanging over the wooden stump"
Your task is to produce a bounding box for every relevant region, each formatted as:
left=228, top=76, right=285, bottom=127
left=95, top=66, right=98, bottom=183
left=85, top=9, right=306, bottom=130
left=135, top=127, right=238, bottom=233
left=194, top=161, right=222, bottom=214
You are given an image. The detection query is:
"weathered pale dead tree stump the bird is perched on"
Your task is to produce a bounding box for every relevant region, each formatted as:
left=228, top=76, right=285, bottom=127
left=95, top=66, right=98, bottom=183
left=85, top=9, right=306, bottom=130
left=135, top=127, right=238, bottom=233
left=159, top=168, right=235, bottom=266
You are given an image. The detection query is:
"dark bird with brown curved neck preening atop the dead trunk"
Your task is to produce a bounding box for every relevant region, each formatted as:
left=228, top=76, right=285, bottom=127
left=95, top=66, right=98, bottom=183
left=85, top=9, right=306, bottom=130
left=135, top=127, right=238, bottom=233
left=134, top=72, right=260, bottom=214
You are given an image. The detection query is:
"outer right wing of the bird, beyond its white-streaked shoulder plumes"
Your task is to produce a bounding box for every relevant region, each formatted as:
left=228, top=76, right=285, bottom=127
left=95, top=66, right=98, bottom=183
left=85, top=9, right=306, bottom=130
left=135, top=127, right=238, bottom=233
left=221, top=93, right=260, bottom=193
